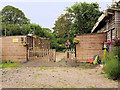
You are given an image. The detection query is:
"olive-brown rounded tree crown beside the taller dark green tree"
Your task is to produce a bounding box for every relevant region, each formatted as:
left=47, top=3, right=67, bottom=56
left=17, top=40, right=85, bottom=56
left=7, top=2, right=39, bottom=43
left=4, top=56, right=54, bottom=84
left=53, top=13, right=72, bottom=38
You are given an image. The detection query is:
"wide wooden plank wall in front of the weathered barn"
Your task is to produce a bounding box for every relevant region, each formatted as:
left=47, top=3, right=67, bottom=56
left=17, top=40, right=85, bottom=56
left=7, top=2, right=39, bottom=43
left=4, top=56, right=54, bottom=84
left=76, top=33, right=106, bottom=62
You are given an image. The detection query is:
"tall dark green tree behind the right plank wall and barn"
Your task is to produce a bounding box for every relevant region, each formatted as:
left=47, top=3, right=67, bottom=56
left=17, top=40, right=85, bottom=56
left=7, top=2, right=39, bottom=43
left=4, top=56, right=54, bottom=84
left=66, top=2, right=102, bottom=34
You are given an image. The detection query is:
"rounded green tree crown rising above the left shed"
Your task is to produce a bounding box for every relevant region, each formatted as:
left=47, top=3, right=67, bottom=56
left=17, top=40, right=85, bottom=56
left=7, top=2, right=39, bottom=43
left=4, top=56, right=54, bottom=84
left=1, top=5, right=30, bottom=25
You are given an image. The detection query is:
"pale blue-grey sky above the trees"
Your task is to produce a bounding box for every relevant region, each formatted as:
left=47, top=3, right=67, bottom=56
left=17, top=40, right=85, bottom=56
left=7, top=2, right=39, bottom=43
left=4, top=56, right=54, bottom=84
left=0, top=0, right=118, bottom=29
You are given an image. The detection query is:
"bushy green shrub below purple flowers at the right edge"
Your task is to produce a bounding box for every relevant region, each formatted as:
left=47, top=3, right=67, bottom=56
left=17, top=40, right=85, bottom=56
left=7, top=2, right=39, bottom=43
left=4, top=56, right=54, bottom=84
left=104, top=48, right=120, bottom=79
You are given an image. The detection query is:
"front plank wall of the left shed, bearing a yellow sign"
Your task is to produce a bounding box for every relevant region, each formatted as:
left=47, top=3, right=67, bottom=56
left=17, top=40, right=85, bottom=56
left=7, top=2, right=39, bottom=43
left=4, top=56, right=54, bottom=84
left=2, top=36, right=27, bottom=62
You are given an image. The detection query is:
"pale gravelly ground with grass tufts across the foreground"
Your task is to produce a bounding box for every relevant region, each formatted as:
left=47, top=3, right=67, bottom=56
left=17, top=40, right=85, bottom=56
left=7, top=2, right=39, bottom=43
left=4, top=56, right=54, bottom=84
left=0, top=66, right=118, bottom=88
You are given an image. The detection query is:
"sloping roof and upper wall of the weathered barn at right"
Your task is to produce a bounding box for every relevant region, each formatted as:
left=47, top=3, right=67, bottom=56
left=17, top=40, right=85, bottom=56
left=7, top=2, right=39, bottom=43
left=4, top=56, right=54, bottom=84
left=91, top=8, right=120, bottom=41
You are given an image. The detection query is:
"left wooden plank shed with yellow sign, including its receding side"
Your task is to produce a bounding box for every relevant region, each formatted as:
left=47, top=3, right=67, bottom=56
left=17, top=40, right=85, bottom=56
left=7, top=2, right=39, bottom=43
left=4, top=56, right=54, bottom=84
left=1, top=36, right=50, bottom=62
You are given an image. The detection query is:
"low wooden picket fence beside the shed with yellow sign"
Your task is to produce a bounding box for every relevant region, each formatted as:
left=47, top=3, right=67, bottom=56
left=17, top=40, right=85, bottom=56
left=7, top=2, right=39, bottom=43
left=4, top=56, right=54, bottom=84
left=28, top=49, right=56, bottom=62
